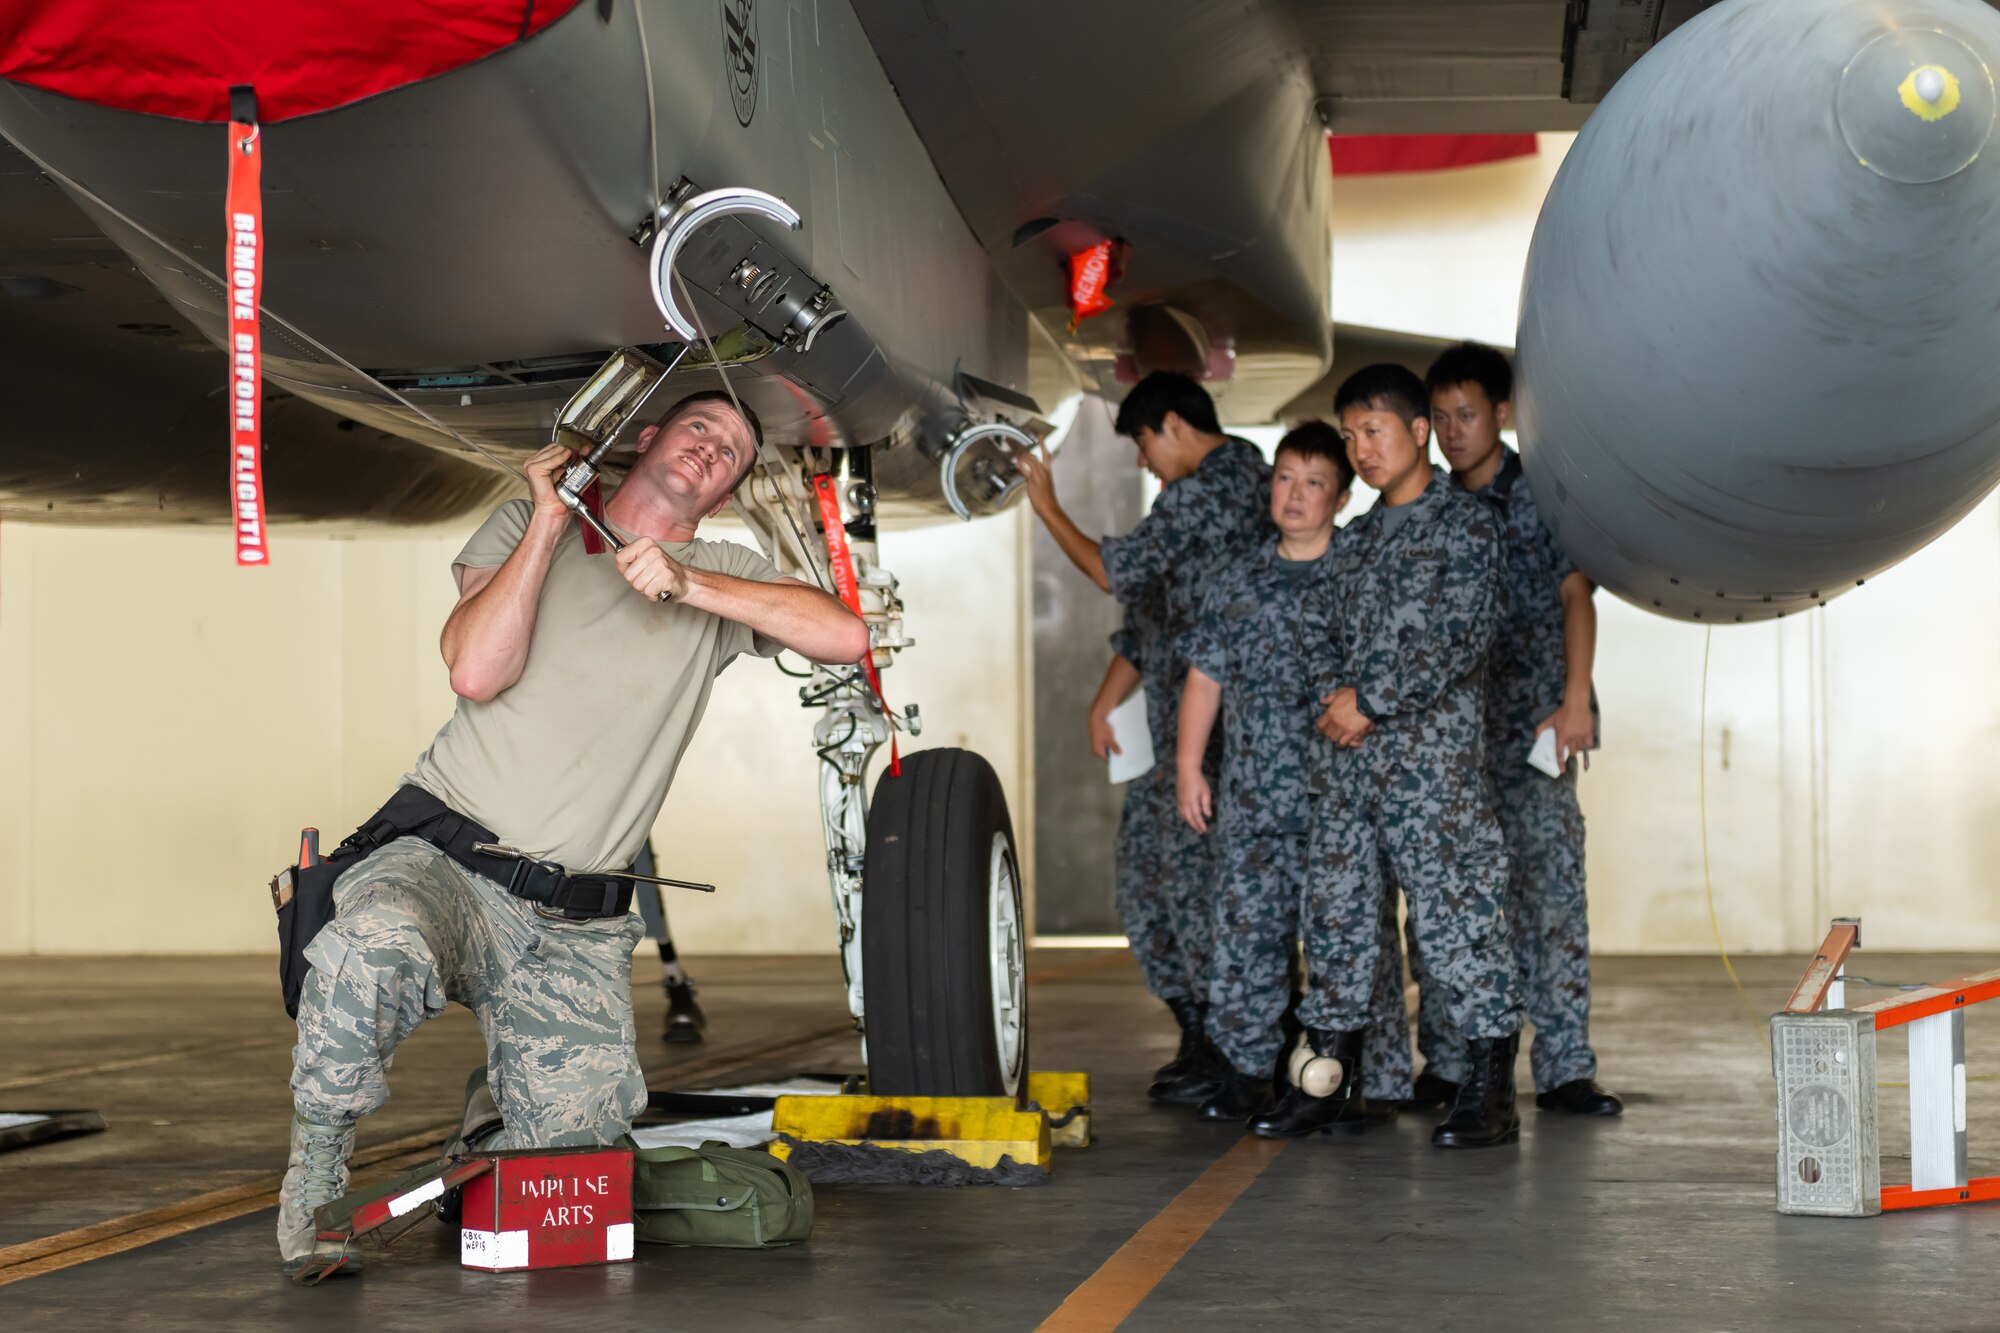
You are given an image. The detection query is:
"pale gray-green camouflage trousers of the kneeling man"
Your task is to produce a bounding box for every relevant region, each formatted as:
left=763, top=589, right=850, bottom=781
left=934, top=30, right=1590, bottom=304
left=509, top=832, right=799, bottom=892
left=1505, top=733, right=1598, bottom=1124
left=292, top=839, right=646, bottom=1149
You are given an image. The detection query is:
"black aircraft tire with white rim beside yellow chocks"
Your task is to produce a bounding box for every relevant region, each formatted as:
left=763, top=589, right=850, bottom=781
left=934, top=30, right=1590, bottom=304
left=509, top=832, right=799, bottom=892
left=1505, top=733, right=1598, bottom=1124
left=862, top=749, right=1028, bottom=1099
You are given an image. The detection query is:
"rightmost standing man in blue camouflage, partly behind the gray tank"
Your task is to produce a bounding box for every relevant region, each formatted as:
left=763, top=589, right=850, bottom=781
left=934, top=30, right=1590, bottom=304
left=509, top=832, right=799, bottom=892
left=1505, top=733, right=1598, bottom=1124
left=1424, top=342, right=1624, bottom=1115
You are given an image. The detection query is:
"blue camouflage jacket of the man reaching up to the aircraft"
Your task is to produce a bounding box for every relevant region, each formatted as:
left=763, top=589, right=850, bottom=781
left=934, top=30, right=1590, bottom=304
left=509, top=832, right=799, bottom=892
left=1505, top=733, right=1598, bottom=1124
left=1098, top=436, right=1274, bottom=748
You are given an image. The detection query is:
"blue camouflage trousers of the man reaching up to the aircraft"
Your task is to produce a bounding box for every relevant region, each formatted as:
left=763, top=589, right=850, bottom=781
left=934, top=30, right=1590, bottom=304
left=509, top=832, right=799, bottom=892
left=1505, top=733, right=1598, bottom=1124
left=1118, top=765, right=1216, bottom=1001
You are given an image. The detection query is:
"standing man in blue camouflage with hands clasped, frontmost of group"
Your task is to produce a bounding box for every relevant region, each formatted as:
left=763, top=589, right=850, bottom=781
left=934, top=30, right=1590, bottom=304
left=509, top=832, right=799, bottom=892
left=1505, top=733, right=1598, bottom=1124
left=1250, top=366, right=1520, bottom=1147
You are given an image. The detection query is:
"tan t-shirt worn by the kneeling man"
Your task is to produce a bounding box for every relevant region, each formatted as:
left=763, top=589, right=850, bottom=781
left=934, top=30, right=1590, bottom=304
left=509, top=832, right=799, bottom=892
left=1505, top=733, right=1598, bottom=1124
left=404, top=500, right=778, bottom=871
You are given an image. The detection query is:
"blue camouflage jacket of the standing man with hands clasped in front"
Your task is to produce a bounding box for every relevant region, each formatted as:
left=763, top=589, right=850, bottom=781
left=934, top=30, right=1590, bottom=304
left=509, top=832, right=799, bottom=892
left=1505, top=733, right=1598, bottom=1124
left=1314, top=468, right=1502, bottom=793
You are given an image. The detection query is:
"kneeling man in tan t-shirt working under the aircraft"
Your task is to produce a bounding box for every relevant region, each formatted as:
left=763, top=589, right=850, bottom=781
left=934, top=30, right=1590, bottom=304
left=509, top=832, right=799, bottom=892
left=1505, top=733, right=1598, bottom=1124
left=278, top=392, right=868, bottom=1277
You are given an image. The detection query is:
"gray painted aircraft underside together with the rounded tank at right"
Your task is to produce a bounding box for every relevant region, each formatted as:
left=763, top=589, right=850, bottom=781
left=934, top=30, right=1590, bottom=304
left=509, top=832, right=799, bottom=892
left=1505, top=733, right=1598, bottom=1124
left=0, top=0, right=2000, bottom=620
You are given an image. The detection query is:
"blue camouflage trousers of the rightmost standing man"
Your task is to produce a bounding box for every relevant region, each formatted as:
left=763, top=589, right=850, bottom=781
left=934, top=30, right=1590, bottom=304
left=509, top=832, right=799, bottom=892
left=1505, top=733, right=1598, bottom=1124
left=1410, top=759, right=1598, bottom=1093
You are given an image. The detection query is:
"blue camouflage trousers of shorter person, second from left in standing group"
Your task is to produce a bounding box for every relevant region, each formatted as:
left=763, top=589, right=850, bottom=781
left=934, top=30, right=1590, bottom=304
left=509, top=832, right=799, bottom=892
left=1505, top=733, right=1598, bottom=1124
left=1208, top=833, right=1410, bottom=1101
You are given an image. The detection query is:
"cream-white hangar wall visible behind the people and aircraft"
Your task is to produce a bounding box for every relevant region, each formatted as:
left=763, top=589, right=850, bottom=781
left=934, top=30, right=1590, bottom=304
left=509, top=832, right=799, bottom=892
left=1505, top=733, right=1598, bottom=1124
left=0, top=136, right=2000, bottom=953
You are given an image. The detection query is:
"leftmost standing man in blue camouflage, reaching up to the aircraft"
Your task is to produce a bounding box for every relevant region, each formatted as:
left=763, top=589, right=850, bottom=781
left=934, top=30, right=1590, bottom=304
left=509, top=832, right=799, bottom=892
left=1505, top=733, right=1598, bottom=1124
left=1018, top=370, right=1270, bottom=1105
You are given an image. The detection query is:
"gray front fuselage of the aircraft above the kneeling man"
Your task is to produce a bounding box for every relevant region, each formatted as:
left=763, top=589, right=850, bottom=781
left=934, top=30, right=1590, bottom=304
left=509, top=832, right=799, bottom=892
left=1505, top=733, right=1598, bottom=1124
left=0, top=4, right=1028, bottom=518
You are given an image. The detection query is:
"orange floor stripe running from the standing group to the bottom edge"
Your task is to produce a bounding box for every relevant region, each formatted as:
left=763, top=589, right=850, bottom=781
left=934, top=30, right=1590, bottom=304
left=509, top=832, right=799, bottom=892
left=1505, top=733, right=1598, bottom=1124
left=1036, top=1135, right=1286, bottom=1333
